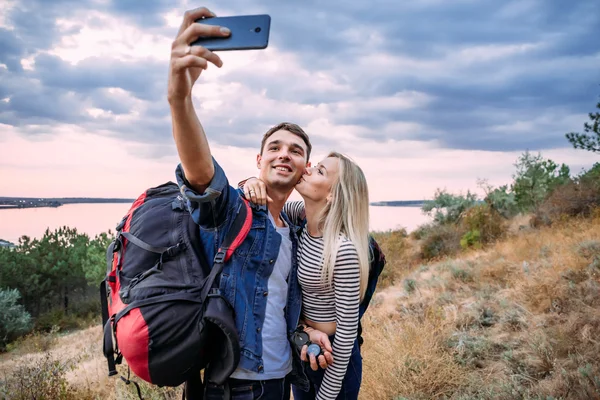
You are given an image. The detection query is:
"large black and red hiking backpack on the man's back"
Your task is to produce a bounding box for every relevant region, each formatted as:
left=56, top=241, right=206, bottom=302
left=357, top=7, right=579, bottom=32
left=100, top=182, right=252, bottom=394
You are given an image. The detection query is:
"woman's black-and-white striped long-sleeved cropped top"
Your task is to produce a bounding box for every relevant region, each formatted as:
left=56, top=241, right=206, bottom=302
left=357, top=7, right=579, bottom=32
left=284, top=202, right=360, bottom=400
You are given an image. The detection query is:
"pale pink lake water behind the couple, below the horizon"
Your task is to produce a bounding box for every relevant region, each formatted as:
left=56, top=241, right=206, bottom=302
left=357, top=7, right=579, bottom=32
left=0, top=203, right=429, bottom=243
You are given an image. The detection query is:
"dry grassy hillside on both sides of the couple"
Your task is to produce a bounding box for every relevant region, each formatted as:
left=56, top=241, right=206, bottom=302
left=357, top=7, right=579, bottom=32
left=0, top=216, right=600, bottom=400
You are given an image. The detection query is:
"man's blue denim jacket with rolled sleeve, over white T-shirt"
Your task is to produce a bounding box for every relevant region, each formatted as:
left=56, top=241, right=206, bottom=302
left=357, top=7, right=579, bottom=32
left=175, top=158, right=308, bottom=388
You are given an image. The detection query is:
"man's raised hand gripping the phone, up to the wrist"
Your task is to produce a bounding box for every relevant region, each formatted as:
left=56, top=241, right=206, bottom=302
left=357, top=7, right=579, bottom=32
left=168, top=7, right=231, bottom=104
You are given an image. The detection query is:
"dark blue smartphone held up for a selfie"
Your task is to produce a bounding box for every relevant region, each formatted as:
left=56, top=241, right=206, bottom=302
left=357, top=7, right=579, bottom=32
left=191, top=14, right=271, bottom=51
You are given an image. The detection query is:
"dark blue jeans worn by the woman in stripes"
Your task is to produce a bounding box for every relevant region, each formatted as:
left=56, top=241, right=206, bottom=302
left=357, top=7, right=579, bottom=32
left=292, top=335, right=362, bottom=400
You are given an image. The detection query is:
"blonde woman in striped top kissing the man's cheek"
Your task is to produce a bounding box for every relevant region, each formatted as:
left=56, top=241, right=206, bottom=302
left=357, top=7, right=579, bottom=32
left=244, top=152, right=369, bottom=400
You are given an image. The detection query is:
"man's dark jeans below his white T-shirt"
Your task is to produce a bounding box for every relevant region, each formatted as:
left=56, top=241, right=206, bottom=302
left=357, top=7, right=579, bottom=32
left=205, top=378, right=290, bottom=400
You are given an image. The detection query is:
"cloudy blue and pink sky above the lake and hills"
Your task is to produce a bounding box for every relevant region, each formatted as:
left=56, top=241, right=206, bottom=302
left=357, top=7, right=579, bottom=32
left=0, top=0, right=600, bottom=201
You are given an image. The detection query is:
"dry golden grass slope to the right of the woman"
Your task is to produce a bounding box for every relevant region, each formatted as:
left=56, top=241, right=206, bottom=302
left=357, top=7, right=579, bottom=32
left=361, top=214, right=600, bottom=399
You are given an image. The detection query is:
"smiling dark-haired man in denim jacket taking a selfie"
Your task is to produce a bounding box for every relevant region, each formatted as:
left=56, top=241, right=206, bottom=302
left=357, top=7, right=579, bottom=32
left=168, top=8, right=332, bottom=399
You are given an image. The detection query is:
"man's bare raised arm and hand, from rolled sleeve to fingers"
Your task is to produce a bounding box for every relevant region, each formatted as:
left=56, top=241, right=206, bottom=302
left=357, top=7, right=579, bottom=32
left=168, top=7, right=230, bottom=194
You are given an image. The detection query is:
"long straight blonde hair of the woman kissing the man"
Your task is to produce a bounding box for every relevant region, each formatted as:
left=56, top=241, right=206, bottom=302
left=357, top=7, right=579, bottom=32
left=319, top=152, right=369, bottom=301
